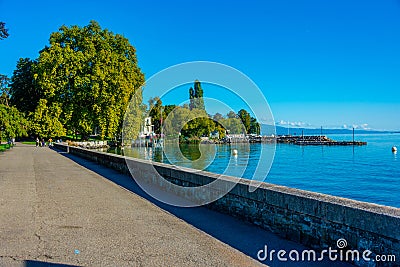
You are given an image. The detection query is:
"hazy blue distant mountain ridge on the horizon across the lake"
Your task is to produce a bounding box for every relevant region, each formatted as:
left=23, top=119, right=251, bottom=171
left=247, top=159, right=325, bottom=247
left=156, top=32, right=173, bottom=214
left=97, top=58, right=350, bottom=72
left=261, top=124, right=396, bottom=135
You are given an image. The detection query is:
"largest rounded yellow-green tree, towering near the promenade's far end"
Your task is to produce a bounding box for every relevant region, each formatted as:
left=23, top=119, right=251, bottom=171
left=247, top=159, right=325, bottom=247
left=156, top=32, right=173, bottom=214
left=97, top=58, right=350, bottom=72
left=34, top=21, right=144, bottom=137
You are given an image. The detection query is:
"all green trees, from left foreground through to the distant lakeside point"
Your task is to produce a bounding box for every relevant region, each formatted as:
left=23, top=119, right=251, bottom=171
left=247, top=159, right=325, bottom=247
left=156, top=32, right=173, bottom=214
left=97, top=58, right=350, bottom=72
left=0, top=21, right=260, bottom=146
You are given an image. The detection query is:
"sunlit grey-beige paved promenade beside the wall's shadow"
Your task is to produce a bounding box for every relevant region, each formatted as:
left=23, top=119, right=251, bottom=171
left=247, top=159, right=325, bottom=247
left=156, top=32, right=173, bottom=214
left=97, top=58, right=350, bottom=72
left=0, top=144, right=259, bottom=267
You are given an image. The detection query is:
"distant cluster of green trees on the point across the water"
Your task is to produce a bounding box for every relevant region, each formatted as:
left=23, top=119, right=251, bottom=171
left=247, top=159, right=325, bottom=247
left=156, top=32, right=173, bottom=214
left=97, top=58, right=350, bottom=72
left=149, top=80, right=261, bottom=141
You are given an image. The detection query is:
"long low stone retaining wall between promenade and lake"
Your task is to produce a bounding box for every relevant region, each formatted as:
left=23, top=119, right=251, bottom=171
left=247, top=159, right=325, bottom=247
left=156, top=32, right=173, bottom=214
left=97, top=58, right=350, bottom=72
left=55, top=144, right=400, bottom=266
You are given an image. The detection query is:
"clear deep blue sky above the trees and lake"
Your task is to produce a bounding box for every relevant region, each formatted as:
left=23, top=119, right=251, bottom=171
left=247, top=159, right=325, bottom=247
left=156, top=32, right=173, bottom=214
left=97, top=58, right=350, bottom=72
left=0, top=0, right=400, bottom=130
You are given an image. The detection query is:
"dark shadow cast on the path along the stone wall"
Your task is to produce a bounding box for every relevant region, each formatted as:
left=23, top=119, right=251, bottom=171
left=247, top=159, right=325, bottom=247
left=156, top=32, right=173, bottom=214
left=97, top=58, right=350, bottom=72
left=56, top=149, right=353, bottom=267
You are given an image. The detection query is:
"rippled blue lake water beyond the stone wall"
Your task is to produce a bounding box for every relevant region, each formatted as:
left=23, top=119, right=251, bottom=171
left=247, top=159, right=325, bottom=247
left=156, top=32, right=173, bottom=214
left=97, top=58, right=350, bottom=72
left=108, top=134, right=400, bottom=208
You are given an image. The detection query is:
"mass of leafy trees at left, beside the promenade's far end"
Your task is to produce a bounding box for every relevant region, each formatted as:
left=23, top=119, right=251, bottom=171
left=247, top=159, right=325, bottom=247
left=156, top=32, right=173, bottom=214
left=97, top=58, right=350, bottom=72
left=0, top=21, right=144, bottom=143
